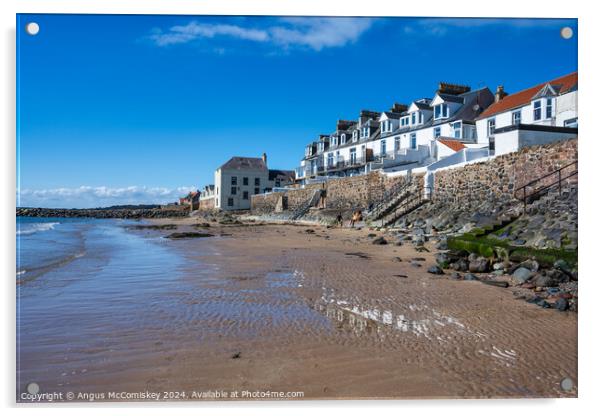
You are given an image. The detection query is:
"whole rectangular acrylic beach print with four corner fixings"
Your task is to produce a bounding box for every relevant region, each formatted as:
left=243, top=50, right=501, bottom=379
left=16, top=14, right=578, bottom=402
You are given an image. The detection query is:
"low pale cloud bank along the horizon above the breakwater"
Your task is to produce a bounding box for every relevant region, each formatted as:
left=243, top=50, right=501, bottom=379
left=17, top=186, right=196, bottom=208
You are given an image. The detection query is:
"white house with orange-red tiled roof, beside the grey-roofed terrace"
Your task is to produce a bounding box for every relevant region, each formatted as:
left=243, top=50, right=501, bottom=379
left=477, top=72, right=578, bottom=156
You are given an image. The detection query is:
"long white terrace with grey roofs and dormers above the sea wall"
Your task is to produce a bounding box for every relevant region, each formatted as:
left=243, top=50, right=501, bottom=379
left=296, top=83, right=494, bottom=182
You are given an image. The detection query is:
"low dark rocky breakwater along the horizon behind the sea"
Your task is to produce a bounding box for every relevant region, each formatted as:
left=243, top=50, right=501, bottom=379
left=17, top=206, right=190, bottom=219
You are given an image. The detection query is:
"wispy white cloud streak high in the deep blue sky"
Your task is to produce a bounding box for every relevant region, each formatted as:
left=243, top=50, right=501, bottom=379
left=149, top=17, right=374, bottom=51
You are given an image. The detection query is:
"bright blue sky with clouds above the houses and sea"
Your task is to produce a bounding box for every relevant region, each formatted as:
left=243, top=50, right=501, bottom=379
left=17, top=15, right=577, bottom=207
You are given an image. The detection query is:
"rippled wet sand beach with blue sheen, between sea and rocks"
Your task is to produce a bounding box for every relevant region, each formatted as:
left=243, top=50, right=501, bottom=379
left=18, top=219, right=577, bottom=401
